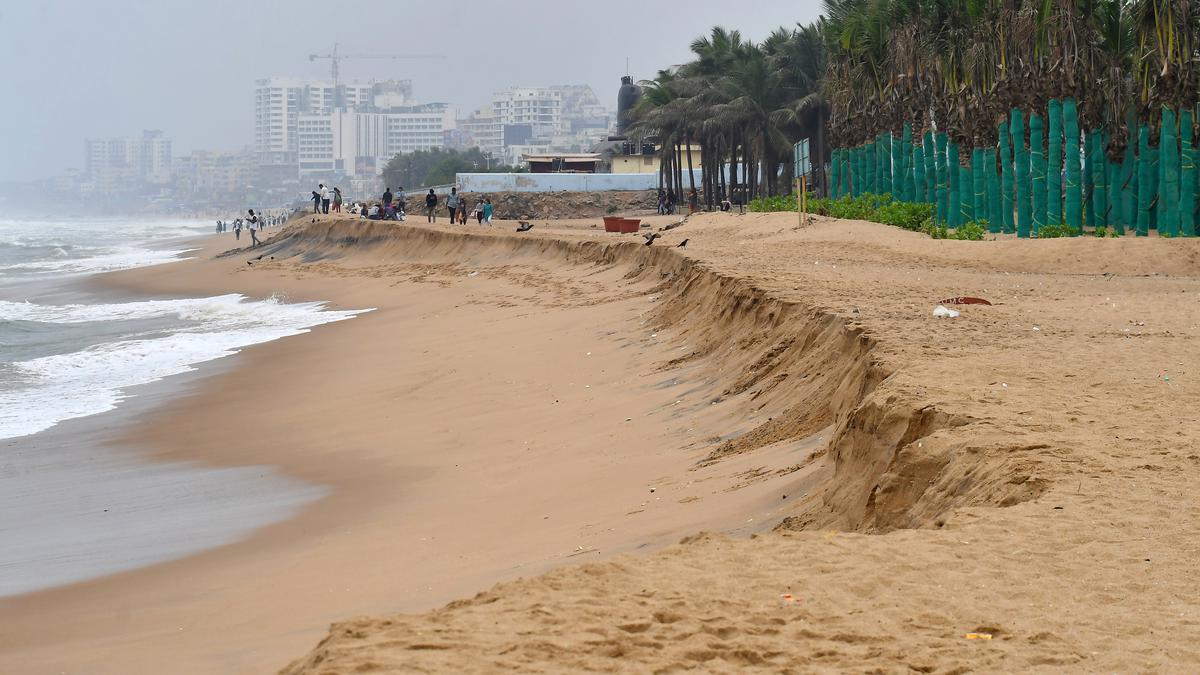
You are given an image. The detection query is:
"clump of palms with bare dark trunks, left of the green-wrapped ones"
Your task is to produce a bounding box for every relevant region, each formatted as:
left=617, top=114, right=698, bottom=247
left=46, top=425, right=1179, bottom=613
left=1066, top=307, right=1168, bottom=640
left=631, top=25, right=828, bottom=207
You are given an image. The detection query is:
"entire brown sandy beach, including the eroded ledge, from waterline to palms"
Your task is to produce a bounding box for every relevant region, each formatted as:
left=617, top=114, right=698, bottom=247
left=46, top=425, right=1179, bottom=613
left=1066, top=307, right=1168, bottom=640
left=0, top=208, right=1200, bottom=674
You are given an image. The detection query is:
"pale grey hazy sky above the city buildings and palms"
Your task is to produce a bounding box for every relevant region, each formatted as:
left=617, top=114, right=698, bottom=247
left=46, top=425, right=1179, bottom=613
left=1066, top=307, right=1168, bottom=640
left=0, top=0, right=821, bottom=180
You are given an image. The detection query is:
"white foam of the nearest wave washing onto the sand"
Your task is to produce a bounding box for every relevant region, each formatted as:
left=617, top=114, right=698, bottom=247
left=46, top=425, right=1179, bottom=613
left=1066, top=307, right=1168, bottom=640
left=0, top=294, right=370, bottom=438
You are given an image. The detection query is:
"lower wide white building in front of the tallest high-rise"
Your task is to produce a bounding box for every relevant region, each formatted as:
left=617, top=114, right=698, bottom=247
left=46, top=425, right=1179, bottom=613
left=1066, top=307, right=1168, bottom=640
left=296, top=103, right=456, bottom=177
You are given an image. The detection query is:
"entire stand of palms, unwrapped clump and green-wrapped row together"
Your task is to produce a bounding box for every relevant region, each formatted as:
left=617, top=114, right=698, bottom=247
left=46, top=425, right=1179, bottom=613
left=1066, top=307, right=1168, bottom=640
left=635, top=0, right=1200, bottom=237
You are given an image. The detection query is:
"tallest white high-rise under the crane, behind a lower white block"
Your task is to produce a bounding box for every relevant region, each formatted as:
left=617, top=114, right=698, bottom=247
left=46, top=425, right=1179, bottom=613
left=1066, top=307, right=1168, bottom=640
left=254, top=77, right=413, bottom=166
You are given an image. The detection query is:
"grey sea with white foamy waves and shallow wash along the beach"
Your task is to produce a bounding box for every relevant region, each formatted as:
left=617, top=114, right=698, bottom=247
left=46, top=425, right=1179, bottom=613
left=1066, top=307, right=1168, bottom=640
left=0, top=219, right=360, bottom=597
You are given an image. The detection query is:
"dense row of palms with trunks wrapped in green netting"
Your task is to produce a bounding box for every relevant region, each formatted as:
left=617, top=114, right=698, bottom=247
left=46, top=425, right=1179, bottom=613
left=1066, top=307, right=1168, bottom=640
left=822, top=0, right=1200, bottom=237
